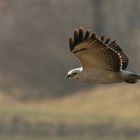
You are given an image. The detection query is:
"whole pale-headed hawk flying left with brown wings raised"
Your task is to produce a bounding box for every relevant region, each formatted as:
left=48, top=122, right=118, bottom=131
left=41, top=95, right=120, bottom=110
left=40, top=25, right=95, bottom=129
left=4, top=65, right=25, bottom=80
left=67, top=27, right=140, bottom=84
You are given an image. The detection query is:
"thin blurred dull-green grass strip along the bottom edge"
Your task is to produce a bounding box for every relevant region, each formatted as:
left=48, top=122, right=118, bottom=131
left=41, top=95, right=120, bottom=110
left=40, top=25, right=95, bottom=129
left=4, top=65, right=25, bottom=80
left=1, top=134, right=139, bottom=140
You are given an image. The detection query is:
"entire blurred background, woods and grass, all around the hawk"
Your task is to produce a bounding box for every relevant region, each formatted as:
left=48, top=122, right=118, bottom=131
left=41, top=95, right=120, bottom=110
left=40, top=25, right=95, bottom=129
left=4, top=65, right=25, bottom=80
left=0, top=0, right=140, bottom=140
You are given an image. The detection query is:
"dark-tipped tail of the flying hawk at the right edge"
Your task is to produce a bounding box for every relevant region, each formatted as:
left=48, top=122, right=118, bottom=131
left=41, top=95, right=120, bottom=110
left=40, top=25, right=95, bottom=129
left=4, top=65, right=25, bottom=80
left=122, top=71, right=140, bottom=84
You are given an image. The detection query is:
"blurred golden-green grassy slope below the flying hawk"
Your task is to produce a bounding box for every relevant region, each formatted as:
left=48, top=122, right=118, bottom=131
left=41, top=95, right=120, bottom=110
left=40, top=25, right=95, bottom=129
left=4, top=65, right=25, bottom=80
left=0, top=85, right=140, bottom=127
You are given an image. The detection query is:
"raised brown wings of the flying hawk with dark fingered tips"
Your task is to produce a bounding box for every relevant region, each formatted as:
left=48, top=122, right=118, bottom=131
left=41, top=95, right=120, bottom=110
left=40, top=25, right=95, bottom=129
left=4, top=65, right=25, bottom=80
left=69, top=28, right=128, bottom=72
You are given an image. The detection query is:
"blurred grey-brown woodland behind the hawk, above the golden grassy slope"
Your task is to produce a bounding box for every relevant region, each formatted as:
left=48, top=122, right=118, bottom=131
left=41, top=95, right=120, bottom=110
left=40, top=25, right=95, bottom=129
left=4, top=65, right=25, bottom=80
left=0, top=0, right=140, bottom=98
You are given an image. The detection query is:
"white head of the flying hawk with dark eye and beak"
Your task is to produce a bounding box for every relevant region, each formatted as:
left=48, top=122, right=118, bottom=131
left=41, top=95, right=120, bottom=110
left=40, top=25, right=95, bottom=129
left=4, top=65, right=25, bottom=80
left=67, top=67, right=83, bottom=80
